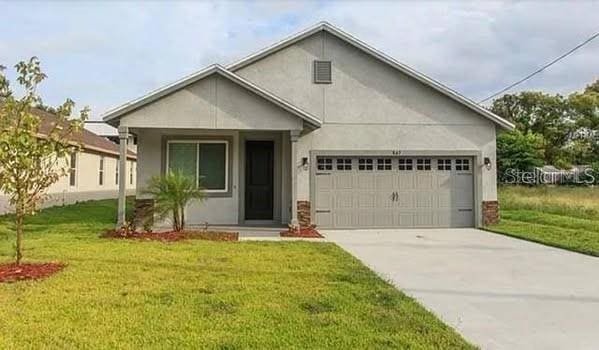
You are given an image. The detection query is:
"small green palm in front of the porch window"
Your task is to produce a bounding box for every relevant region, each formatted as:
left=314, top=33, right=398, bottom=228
left=144, top=171, right=206, bottom=232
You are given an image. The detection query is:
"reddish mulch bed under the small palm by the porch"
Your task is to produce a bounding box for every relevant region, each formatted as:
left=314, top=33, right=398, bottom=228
left=102, top=230, right=239, bottom=242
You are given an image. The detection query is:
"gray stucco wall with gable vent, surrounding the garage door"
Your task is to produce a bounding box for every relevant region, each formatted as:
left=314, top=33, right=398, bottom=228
left=236, top=32, right=497, bottom=208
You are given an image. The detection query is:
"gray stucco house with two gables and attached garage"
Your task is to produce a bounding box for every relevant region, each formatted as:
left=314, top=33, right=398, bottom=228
left=104, top=23, right=513, bottom=228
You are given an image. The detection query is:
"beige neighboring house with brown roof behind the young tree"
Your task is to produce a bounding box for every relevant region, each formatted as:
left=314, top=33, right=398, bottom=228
left=0, top=109, right=137, bottom=214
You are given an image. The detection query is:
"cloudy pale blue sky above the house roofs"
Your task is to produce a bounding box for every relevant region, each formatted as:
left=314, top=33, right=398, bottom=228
left=0, top=0, right=599, bottom=119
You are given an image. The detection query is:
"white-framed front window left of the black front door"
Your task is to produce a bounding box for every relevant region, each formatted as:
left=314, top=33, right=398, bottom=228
left=166, top=140, right=229, bottom=192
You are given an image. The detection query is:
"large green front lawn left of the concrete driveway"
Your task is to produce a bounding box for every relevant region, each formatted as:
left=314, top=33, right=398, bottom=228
left=0, top=201, right=472, bottom=349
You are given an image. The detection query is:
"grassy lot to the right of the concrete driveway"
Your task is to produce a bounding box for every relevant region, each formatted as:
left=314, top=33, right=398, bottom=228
left=488, top=186, right=599, bottom=256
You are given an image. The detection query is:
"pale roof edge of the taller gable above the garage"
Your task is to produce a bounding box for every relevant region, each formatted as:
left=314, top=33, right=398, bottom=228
left=227, top=22, right=515, bottom=129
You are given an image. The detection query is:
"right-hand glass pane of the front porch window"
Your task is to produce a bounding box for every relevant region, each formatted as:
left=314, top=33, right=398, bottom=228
left=198, top=142, right=227, bottom=190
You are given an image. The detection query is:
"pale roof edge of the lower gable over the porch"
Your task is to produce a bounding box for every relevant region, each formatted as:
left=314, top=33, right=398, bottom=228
left=102, top=64, right=322, bottom=128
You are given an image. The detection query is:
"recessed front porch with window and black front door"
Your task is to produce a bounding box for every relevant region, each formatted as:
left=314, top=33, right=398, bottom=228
left=119, top=127, right=302, bottom=229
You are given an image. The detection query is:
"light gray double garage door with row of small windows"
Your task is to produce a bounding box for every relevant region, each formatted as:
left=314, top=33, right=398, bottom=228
left=313, top=156, right=474, bottom=228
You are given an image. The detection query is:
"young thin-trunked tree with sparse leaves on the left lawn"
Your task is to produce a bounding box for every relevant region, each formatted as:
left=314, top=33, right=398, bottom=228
left=0, top=57, right=89, bottom=264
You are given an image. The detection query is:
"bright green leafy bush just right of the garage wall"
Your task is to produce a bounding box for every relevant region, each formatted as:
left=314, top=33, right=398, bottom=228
left=497, top=130, right=543, bottom=177
